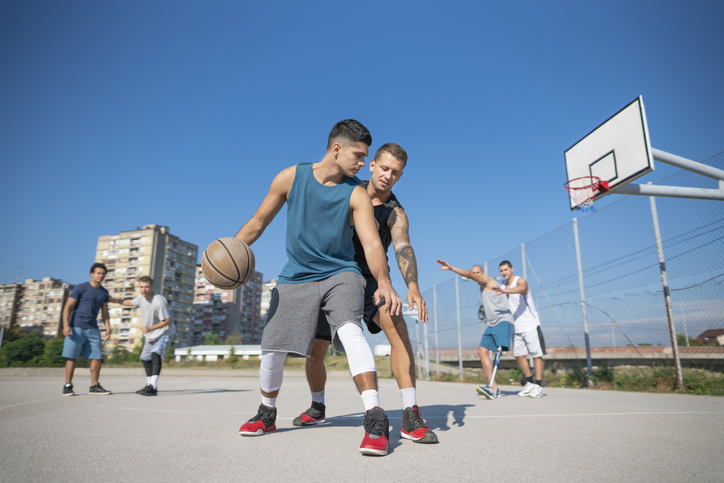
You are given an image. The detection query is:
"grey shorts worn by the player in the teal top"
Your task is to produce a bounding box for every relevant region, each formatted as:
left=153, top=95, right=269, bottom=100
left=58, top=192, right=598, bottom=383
left=261, top=272, right=365, bottom=357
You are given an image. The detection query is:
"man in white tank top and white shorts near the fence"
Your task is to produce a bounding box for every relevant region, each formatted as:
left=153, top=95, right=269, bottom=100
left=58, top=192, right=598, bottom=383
left=499, top=260, right=545, bottom=398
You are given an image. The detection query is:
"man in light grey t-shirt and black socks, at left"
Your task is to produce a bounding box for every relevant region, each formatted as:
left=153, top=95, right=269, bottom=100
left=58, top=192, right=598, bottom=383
left=109, top=275, right=176, bottom=396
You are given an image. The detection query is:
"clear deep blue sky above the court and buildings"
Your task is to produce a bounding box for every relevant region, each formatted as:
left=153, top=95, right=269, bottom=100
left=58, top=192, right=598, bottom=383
left=0, top=0, right=724, bottom=297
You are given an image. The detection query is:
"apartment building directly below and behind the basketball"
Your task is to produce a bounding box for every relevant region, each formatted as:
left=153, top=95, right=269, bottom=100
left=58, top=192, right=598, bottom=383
left=189, top=265, right=262, bottom=346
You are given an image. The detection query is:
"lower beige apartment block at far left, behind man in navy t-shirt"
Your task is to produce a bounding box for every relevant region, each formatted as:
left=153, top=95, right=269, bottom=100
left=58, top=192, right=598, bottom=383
left=10, top=277, right=75, bottom=338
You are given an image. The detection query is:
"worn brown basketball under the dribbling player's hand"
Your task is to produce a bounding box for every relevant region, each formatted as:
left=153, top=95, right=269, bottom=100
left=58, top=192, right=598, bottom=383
left=201, top=237, right=255, bottom=290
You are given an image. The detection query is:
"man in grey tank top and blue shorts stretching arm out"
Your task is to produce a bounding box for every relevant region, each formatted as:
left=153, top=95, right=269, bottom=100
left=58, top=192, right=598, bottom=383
left=437, top=260, right=513, bottom=399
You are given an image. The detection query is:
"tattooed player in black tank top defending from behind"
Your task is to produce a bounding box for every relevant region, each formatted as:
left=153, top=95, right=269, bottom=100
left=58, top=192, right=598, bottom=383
left=294, top=143, right=438, bottom=443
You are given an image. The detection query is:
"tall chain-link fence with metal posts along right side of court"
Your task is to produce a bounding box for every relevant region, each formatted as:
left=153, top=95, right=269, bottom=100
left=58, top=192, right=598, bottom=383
left=412, top=152, right=724, bottom=394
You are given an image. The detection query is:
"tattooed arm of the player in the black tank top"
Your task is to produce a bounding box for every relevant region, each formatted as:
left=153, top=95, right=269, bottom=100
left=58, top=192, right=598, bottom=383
left=394, top=206, right=427, bottom=322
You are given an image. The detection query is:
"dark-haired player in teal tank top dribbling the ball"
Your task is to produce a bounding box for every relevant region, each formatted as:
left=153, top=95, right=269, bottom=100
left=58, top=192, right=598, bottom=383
left=236, top=119, right=402, bottom=455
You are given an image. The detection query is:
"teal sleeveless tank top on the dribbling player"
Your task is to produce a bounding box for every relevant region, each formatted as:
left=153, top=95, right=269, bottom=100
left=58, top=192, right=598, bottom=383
left=278, top=163, right=360, bottom=283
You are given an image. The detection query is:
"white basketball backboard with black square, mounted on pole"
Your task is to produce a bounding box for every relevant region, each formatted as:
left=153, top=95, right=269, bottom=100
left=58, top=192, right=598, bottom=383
left=564, top=96, right=654, bottom=210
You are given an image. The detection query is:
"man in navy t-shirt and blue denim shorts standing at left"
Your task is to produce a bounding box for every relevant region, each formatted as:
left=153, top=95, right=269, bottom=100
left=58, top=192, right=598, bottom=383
left=63, top=263, right=111, bottom=396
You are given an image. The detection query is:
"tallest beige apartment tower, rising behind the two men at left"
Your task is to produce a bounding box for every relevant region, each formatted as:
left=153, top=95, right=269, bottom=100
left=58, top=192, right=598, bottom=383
left=96, top=225, right=198, bottom=350
